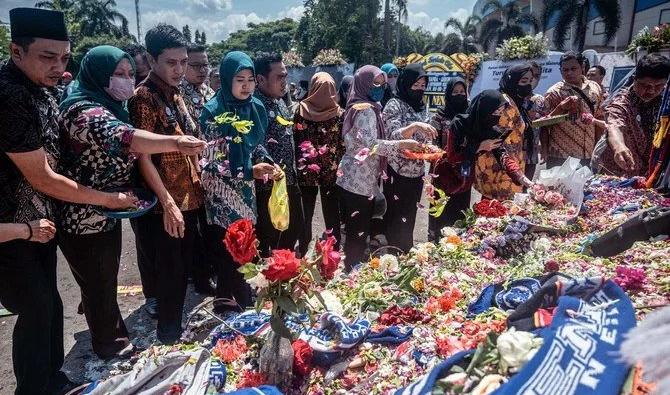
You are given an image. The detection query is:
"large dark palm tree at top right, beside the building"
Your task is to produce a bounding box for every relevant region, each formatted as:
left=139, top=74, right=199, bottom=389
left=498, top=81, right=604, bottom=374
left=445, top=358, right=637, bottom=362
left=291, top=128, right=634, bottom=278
left=542, top=0, right=621, bottom=52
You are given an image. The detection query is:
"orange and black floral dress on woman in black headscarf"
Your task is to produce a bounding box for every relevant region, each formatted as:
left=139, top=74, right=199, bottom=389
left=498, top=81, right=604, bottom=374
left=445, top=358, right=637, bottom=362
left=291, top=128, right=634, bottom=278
left=475, top=95, right=526, bottom=200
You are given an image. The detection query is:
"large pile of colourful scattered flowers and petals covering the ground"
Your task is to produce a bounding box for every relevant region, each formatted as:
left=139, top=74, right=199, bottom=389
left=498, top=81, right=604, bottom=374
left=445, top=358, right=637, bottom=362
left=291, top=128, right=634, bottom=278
left=93, top=176, right=670, bottom=395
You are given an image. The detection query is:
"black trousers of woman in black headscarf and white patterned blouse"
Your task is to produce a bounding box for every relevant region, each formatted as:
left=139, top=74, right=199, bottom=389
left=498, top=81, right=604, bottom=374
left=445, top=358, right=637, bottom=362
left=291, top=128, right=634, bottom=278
left=384, top=166, right=423, bottom=252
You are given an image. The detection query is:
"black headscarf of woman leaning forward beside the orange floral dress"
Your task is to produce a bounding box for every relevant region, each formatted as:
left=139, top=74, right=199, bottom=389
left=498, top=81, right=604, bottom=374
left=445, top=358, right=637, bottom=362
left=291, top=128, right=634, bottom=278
left=451, top=89, right=506, bottom=159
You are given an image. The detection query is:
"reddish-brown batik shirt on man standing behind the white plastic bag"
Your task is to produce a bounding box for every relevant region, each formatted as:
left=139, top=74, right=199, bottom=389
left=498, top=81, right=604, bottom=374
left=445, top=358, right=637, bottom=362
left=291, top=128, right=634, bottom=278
left=544, top=78, right=602, bottom=159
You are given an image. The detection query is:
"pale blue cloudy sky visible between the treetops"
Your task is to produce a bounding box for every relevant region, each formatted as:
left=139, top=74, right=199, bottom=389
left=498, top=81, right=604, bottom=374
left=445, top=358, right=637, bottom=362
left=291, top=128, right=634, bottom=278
left=0, top=0, right=484, bottom=43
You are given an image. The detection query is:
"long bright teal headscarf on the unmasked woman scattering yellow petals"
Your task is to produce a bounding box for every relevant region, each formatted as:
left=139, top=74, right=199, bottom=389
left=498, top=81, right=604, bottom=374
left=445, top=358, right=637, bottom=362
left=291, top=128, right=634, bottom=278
left=200, top=51, right=268, bottom=178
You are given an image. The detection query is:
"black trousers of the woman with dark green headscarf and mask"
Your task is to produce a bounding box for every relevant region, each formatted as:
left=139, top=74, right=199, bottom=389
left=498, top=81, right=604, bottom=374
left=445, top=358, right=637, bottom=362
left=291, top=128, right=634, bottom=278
left=58, top=221, right=130, bottom=358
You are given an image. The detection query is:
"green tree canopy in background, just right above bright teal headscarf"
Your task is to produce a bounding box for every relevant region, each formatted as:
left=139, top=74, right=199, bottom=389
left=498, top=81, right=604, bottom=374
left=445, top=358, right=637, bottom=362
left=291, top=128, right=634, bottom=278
left=207, top=18, right=298, bottom=61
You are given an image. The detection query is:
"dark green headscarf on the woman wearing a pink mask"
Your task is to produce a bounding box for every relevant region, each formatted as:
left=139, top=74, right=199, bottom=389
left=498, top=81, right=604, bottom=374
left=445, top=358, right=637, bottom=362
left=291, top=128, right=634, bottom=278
left=60, top=45, right=135, bottom=122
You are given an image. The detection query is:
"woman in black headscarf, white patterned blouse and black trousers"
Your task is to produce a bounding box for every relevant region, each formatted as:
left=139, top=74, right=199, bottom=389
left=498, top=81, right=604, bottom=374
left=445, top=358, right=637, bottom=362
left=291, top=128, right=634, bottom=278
left=382, top=63, right=437, bottom=252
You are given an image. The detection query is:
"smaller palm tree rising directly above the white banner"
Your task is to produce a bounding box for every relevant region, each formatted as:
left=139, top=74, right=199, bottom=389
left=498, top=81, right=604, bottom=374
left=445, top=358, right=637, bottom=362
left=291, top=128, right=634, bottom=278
left=479, top=0, right=544, bottom=50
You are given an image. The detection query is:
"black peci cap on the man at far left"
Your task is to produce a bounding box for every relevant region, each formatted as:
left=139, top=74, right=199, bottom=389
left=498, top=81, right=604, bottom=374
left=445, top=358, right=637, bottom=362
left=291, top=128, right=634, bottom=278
left=9, top=8, right=70, bottom=41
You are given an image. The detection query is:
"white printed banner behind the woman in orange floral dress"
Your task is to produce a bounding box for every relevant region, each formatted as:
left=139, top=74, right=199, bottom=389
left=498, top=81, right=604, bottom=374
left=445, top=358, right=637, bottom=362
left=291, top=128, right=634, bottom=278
left=470, top=54, right=562, bottom=97
